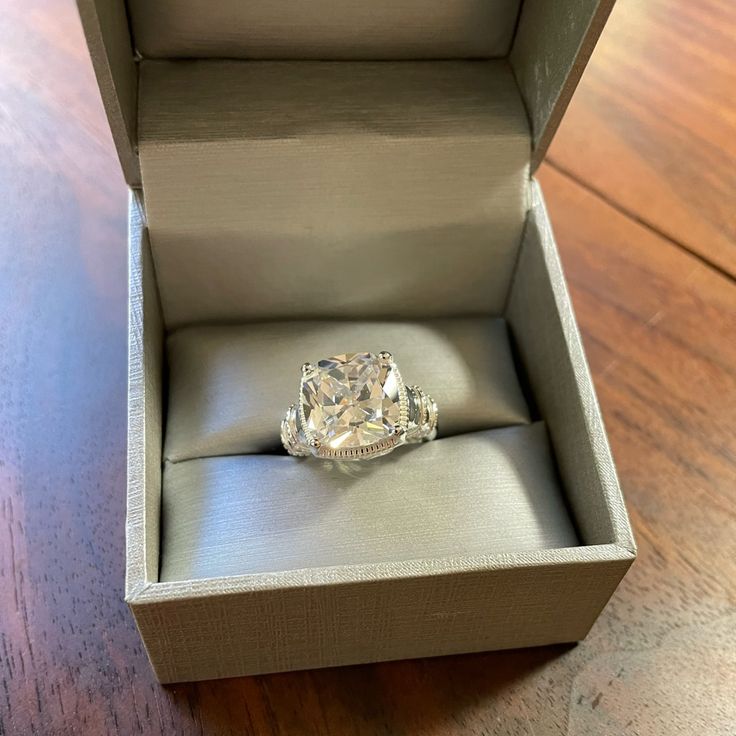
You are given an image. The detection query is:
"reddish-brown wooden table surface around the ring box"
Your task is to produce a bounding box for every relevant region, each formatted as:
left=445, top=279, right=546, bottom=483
left=0, top=0, right=736, bottom=736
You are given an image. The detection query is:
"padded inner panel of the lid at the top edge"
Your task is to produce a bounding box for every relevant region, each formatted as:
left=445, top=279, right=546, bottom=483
left=128, top=0, right=520, bottom=60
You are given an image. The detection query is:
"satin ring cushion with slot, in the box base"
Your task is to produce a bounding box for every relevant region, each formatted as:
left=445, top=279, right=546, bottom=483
left=161, top=317, right=588, bottom=580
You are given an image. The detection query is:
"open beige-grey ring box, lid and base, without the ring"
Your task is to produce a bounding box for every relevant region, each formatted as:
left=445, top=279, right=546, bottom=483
left=79, top=0, right=636, bottom=682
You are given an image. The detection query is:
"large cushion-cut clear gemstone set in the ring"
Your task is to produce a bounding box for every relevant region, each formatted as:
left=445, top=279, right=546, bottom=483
left=301, top=353, right=400, bottom=450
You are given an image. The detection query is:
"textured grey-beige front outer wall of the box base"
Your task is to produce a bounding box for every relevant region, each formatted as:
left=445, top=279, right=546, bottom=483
left=130, top=545, right=632, bottom=682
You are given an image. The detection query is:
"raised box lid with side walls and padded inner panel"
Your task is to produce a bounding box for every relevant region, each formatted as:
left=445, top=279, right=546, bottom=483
left=78, top=0, right=614, bottom=187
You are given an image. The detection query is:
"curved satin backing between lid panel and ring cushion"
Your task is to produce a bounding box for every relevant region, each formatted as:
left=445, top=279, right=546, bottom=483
left=138, top=60, right=531, bottom=328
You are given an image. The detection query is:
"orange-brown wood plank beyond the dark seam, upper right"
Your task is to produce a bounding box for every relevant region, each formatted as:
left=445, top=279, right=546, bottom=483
left=548, top=0, right=736, bottom=276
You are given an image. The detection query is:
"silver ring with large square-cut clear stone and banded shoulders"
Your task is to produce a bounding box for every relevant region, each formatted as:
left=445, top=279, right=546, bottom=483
left=281, top=351, right=438, bottom=460
